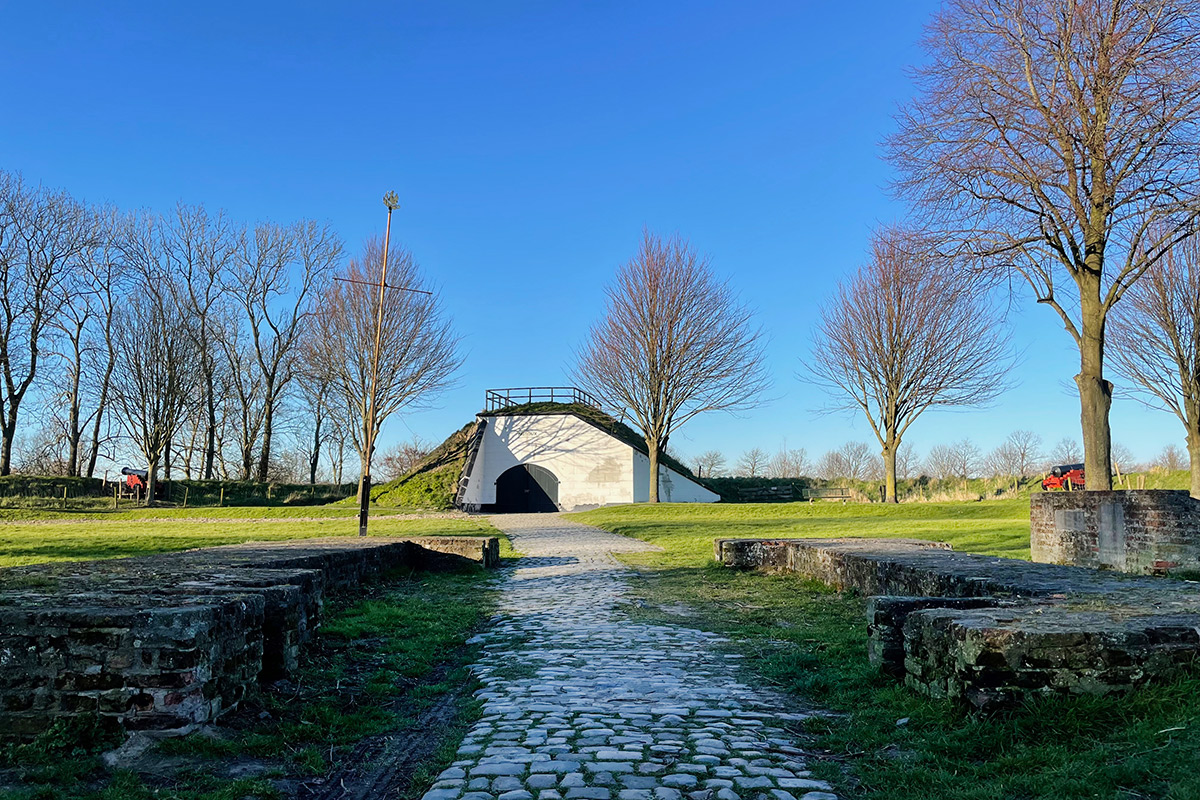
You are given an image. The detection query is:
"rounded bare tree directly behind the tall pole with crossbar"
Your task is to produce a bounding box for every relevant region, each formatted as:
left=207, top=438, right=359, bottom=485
left=306, top=239, right=462, bottom=501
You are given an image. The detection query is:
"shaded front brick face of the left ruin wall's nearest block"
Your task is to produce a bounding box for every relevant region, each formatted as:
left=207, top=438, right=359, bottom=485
left=0, top=595, right=263, bottom=736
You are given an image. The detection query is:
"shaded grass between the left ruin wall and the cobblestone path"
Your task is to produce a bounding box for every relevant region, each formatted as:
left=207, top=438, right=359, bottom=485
left=0, top=563, right=494, bottom=800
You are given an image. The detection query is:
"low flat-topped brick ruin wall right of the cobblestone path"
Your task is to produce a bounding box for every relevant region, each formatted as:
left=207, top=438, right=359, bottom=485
left=714, top=539, right=1200, bottom=708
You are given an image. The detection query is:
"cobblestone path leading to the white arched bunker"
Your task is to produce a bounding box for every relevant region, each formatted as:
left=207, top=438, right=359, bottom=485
left=424, top=515, right=838, bottom=800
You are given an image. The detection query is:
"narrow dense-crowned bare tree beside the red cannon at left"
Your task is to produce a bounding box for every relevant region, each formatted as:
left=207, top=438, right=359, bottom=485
left=112, top=284, right=203, bottom=504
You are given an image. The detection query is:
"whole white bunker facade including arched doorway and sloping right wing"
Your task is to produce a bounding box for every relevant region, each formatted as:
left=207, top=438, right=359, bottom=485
left=458, top=411, right=720, bottom=512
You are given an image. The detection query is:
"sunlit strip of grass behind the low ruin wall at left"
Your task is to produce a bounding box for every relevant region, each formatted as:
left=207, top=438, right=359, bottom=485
left=0, top=509, right=496, bottom=567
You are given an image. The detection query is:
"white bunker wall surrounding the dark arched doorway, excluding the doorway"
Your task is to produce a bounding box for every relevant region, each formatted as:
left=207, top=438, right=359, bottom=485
left=463, top=414, right=635, bottom=511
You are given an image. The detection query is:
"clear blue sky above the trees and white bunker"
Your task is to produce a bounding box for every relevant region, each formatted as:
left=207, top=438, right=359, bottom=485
left=0, top=0, right=1183, bottom=461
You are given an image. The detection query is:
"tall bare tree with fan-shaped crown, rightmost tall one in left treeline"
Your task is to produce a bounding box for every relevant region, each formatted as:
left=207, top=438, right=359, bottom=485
left=229, top=222, right=342, bottom=481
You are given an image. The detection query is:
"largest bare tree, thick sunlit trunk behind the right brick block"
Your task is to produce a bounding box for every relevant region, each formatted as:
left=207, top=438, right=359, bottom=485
left=889, top=0, right=1200, bottom=489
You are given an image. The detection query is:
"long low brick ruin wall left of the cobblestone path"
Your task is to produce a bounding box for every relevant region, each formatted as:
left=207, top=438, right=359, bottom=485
left=0, top=536, right=499, bottom=738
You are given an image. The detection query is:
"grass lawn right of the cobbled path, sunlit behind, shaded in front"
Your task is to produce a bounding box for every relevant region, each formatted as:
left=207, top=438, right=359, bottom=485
left=572, top=500, right=1200, bottom=800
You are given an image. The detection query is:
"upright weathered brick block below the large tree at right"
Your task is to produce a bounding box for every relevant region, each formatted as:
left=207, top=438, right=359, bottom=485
left=1030, top=489, right=1200, bottom=575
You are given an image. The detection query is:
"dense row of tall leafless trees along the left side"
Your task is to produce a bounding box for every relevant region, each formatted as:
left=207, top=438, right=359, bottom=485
left=0, top=173, right=457, bottom=491
